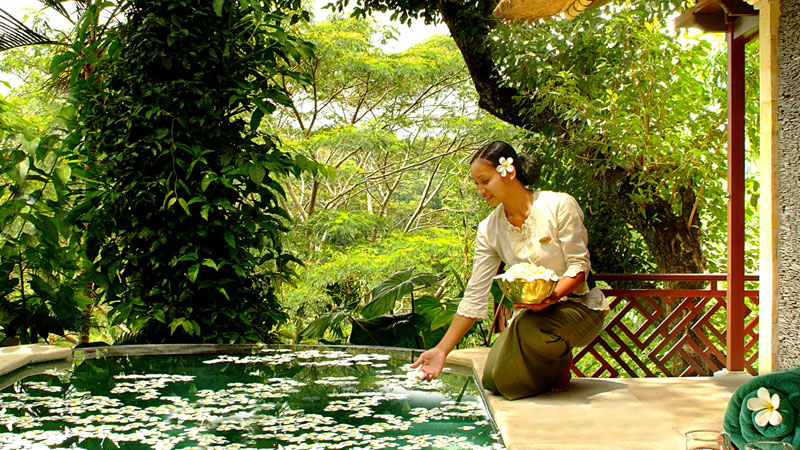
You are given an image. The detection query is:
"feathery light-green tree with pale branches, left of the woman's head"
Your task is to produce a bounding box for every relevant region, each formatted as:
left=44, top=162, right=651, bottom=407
left=265, top=15, right=511, bottom=243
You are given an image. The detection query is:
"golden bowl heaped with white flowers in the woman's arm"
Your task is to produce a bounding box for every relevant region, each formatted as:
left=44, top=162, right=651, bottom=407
left=495, top=263, right=558, bottom=305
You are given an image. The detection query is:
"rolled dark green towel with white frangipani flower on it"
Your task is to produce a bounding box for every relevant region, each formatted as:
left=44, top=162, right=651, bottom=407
left=723, top=367, right=800, bottom=449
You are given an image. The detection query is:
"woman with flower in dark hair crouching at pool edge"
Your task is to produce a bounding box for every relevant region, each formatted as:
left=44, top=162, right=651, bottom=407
left=411, top=141, right=608, bottom=400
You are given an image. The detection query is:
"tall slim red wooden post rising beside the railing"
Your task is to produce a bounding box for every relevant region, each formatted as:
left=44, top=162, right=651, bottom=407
left=726, top=25, right=746, bottom=371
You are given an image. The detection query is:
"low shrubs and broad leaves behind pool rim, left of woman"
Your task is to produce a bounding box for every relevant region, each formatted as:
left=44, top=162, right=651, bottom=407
left=282, top=224, right=499, bottom=348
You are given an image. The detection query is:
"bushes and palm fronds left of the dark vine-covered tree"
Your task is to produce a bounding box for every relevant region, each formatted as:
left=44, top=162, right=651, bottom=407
left=0, top=0, right=148, bottom=343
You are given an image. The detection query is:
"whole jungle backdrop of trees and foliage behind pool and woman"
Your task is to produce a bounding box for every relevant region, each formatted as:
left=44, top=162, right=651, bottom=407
left=0, top=0, right=758, bottom=356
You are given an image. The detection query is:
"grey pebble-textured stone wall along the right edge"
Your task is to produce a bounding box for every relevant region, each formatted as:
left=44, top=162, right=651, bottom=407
left=777, top=0, right=800, bottom=370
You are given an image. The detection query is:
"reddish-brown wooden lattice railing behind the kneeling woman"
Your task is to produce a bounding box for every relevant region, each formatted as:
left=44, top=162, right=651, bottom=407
left=572, top=274, right=758, bottom=378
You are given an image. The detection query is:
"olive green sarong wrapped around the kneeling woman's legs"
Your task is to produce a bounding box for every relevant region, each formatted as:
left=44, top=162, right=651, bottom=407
left=483, top=301, right=604, bottom=400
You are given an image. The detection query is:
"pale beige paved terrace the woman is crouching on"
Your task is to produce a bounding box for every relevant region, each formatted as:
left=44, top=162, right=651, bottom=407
left=447, top=348, right=750, bottom=450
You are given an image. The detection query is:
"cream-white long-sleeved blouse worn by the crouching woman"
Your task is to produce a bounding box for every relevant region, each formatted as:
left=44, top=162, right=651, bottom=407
left=457, top=191, right=608, bottom=319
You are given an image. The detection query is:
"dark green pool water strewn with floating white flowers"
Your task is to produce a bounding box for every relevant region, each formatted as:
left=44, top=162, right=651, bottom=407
left=0, top=348, right=503, bottom=450
